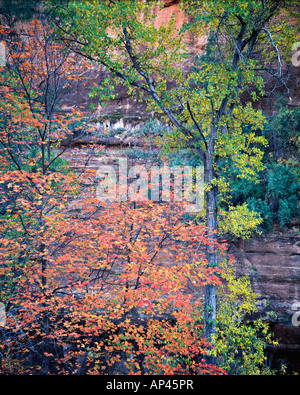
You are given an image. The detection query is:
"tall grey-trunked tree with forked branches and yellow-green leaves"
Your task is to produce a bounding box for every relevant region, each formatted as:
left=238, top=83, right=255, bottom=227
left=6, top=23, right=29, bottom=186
left=48, top=0, right=298, bottom=354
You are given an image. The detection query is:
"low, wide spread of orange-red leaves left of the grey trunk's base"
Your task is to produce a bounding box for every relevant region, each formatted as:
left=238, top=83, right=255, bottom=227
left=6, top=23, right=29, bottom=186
left=1, top=190, right=229, bottom=374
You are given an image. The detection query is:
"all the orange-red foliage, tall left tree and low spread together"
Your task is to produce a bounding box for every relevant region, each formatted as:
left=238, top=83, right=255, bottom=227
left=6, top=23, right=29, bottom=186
left=0, top=21, right=225, bottom=374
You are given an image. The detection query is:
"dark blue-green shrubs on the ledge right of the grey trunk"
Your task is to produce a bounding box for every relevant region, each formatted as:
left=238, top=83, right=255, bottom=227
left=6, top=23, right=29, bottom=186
left=220, top=96, right=299, bottom=232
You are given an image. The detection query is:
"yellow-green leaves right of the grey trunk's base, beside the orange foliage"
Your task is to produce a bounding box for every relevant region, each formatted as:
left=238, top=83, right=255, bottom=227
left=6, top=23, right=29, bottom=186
left=213, top=264, right=278, bottom=375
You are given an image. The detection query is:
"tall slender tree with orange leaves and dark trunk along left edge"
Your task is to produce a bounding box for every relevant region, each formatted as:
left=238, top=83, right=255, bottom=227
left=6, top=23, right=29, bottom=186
left=0, top=20, right=91, bottom=372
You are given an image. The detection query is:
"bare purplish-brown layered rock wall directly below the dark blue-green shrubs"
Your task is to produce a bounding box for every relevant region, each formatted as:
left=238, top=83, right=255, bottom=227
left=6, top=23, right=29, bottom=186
left=228, top=235, right=300, bottom=324
